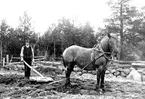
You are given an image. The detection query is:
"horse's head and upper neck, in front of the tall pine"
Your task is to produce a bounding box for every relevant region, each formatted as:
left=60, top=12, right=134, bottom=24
left=101, top=33, right=120, bottom=57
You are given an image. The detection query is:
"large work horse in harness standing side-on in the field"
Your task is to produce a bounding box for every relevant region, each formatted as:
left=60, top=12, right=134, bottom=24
left=62, top=33, right=119, bottom=91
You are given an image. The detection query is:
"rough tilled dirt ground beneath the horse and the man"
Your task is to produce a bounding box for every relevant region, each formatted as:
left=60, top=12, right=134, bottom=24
left=0, top=63, right=145, bottom=99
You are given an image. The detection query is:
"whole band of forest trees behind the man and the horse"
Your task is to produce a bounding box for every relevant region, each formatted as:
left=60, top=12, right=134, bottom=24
left=0, top=0, right=145, bottom=60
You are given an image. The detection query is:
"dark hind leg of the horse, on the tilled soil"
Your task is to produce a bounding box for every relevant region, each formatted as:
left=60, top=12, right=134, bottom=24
left=65, top=62, right=74, bottom=86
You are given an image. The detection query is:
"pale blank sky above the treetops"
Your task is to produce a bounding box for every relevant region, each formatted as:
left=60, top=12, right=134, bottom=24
left=0, top=0, right=145, bottom=33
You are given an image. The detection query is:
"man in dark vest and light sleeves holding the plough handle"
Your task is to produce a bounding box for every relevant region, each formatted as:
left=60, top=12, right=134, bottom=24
left=20, top=40, right=34, bottom=79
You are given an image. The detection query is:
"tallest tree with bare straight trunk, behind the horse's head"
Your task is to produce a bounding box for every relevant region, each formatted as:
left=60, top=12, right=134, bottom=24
left=105, top=0, right=140, bottom=60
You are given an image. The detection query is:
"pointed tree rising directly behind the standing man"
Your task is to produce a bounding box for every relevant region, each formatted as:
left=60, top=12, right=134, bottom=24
left=6, top=12, right=38, bottom=57
